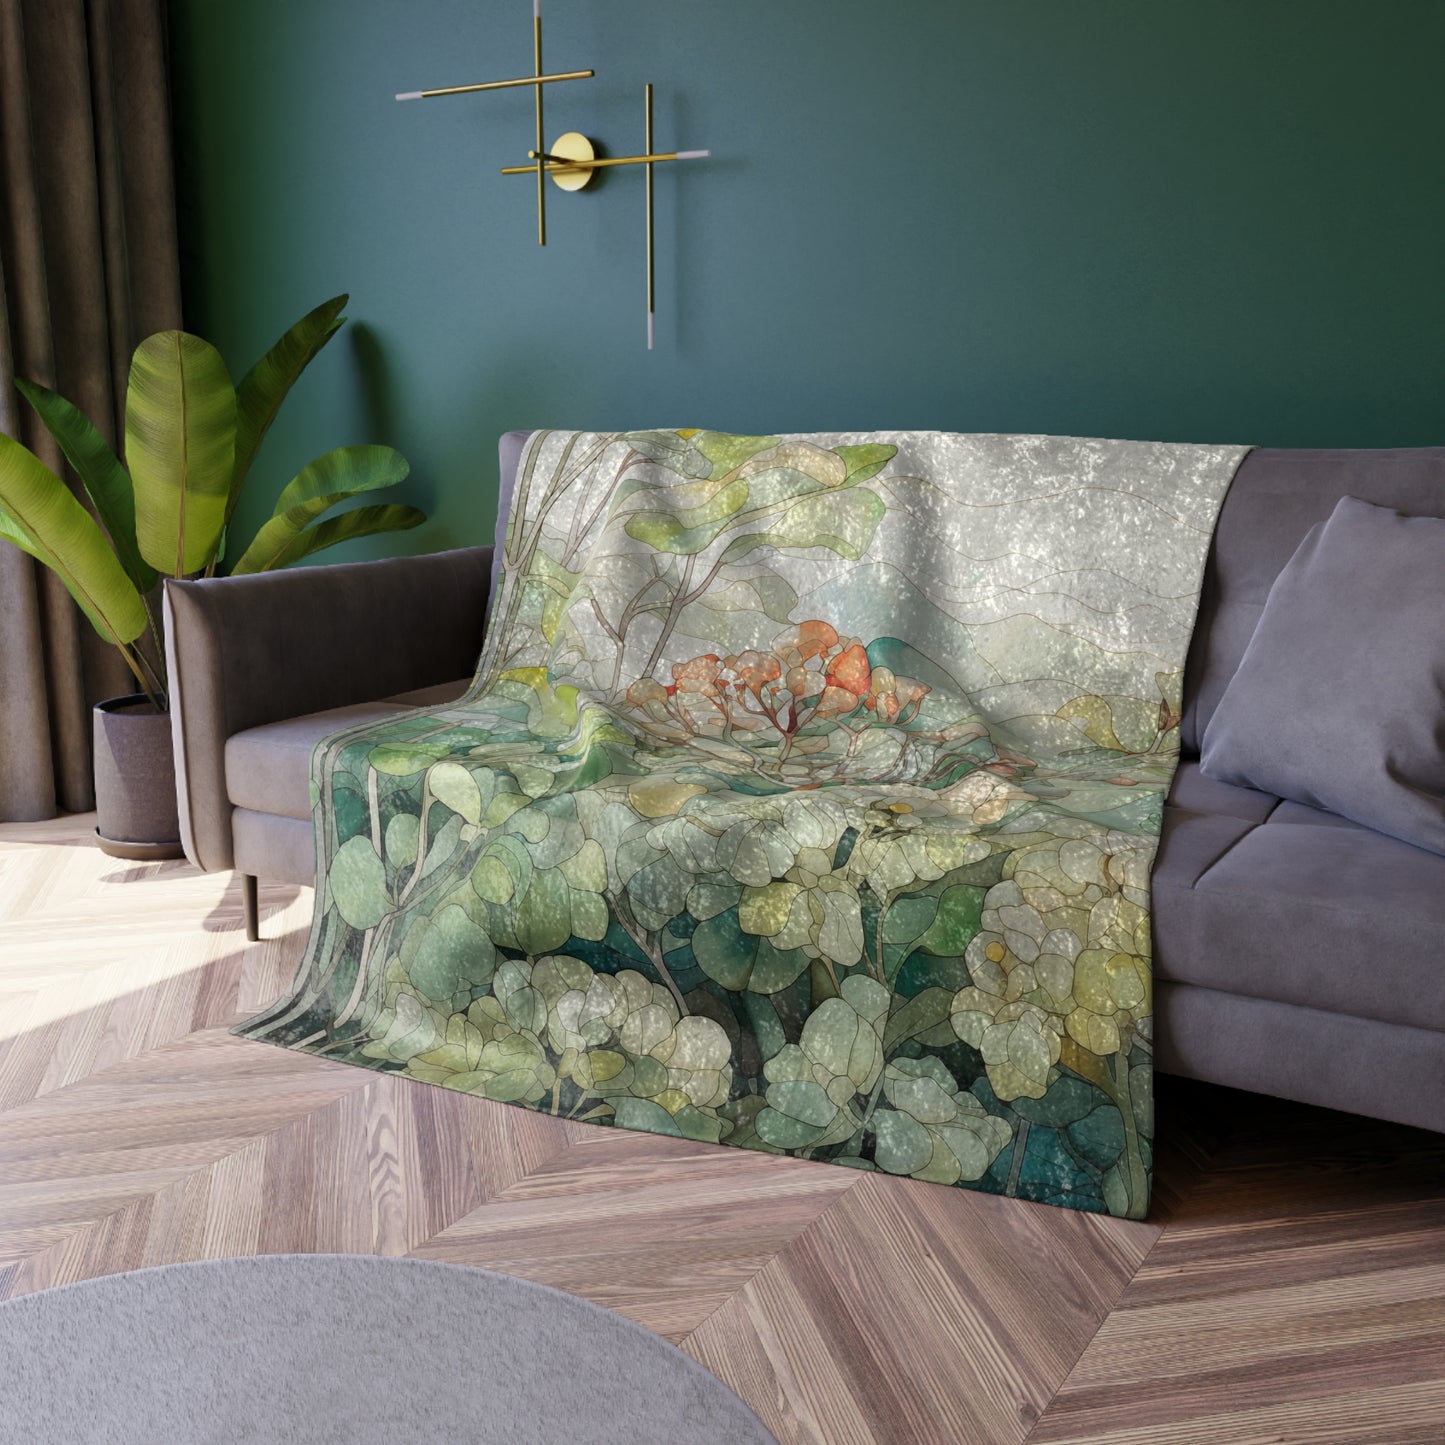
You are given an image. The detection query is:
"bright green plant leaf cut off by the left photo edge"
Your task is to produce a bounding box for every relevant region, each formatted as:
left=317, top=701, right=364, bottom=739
left=0, top=435, right=146, bottom=644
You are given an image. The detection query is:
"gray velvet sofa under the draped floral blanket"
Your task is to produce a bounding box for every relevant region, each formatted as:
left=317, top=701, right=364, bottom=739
left=166, top=432, right=1445, bottom=1131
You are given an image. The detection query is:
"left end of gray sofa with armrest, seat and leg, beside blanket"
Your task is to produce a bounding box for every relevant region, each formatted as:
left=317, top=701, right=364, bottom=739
left=165, top=546, right=493, bottom=941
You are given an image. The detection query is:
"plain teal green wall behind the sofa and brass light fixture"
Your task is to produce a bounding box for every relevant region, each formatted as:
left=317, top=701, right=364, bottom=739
left=172, top=0, right=1445, bottom=559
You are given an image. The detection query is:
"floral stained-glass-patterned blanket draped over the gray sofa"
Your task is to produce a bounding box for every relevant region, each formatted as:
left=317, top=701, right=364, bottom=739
left=238, top=431, right=1244, bottom=1218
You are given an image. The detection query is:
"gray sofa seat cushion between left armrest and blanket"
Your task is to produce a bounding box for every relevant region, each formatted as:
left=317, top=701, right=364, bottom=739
left=225, top=678, right=471, bottom=819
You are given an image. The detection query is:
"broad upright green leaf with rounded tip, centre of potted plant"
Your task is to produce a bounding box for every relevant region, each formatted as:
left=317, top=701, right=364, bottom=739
left=126, top=331, right=236, bottom=577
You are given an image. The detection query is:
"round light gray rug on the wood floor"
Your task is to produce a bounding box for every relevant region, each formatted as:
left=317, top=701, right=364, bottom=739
left=0, top=1254, right=776, bottom=1445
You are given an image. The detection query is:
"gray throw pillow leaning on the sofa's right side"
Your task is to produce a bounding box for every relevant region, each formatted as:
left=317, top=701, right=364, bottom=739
left=1199, top=497, right=1445, bottom=854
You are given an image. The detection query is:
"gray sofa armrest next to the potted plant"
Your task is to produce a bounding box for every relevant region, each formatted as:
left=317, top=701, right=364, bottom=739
left=165, top=546, right=493, bottom=871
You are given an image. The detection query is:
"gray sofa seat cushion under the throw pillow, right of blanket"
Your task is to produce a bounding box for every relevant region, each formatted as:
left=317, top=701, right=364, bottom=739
left=1153, top=803, right=1445, bottom=1030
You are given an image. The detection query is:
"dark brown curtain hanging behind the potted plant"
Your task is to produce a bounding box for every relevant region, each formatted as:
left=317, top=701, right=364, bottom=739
left=0, top=0, right=181, bottom=822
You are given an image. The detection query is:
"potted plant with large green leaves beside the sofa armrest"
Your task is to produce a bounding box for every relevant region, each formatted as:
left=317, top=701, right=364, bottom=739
left=0, top=296, right=426, bottom=858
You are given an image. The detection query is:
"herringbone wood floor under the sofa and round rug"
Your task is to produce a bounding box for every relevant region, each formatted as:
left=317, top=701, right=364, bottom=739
left=8, top=818, right=1445, bottom=1445
